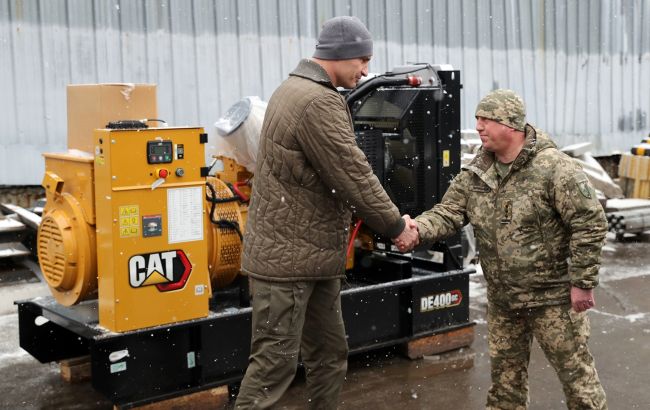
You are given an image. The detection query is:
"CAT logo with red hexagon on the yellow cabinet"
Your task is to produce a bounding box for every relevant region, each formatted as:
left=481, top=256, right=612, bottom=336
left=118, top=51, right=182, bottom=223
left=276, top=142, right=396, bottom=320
left=129, top=249, right=192, bottom=292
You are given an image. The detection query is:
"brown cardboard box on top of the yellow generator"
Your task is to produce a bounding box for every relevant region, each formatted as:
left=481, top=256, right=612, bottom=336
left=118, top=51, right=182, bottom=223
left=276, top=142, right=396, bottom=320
left=68, top=83, right=158, bottom=153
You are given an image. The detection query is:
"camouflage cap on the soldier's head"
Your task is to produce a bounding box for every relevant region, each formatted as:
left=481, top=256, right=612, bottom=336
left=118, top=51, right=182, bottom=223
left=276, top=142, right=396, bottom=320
left=475, top=89, right=526, bottom=131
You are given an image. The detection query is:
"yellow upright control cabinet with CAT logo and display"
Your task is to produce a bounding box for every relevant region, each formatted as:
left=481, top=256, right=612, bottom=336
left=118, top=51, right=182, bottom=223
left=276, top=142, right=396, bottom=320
left=95, top=128, right=211, bottom=332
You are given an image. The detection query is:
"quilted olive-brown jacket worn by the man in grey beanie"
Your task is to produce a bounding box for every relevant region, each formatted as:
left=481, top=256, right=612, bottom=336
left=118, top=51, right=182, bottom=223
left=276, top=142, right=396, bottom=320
left=242, top=59, right=404, bottom=281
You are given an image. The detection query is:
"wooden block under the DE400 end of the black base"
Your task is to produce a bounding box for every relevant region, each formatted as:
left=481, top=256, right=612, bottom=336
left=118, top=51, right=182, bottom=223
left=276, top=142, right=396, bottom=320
left=402, top=326, right=474, bottom=360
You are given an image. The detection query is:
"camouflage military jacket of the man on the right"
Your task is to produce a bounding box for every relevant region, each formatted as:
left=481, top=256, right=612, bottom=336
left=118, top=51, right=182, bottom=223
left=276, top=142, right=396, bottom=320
left=416, top=125, right=607, bottom=309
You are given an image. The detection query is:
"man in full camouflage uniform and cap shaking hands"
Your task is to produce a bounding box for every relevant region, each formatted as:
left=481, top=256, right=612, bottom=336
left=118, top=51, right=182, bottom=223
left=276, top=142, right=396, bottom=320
left=396, top=90, right=607, bottom=409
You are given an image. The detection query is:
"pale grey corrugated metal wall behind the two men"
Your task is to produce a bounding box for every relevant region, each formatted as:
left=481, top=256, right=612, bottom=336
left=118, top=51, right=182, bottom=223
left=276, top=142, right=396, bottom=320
left=0, top=0, right=650, bottom=185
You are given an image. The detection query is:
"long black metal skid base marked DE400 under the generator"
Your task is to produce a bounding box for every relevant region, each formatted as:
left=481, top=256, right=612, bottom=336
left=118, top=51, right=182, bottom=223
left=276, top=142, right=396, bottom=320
left=16, top=254, right=473, bottom=408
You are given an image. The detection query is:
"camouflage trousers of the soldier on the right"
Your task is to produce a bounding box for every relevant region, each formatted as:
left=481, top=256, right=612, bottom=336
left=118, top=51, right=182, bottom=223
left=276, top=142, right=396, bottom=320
left=486, top=305, right=607, bottom=409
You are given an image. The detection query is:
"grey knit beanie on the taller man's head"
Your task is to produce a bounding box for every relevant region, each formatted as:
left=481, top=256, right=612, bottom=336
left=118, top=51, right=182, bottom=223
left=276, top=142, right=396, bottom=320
left=314, top=16, right=372, bottom=60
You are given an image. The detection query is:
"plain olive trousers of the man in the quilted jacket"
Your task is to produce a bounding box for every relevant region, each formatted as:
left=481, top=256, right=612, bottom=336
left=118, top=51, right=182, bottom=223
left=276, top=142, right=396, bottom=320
left=235, top=278, right=348, bottom=409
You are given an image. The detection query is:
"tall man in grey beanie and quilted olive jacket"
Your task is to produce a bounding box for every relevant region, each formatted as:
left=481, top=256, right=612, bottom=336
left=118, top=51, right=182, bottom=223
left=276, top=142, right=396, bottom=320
left=235, top=16, right=417, bottom=409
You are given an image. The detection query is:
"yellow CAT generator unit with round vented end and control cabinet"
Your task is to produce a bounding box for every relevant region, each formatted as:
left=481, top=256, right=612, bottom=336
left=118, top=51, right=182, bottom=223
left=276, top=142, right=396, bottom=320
left=38, top=86, right=251, bottom=332
